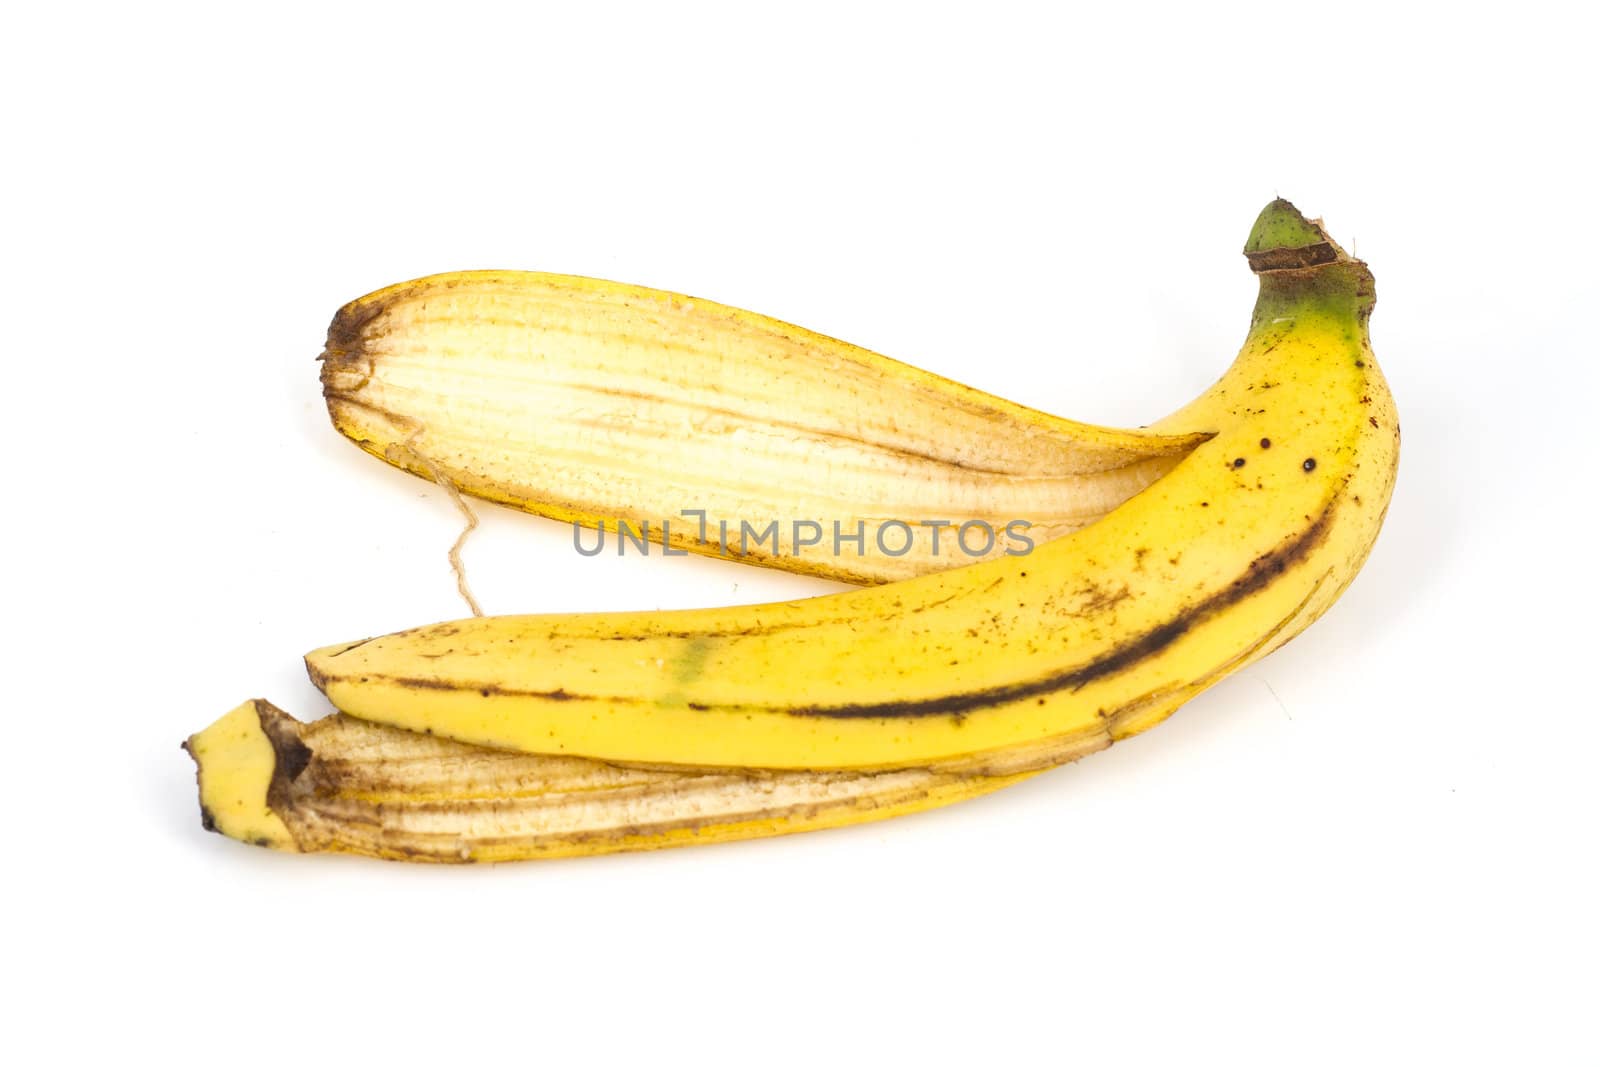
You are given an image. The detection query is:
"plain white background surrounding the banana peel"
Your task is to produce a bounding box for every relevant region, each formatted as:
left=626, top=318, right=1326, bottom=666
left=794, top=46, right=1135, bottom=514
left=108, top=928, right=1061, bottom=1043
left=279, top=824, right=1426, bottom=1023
left=0, top=3, right=1600, bottom=1064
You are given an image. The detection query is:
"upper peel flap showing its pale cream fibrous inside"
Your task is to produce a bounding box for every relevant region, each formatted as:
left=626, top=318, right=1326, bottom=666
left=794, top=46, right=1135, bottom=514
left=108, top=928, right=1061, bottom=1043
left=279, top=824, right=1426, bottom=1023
left=322, top=270, right=1203, bottom=584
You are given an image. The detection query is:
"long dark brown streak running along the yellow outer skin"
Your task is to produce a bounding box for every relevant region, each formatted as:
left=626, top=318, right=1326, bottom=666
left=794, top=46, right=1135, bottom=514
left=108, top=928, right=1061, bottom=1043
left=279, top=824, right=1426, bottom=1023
left=321, top=502, right=1338, bottom=720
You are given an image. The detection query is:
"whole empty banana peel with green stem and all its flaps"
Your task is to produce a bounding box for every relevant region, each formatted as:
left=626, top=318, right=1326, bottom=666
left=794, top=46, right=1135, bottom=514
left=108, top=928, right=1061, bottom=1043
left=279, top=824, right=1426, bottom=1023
left=189, top=200, right=1398, bottom=859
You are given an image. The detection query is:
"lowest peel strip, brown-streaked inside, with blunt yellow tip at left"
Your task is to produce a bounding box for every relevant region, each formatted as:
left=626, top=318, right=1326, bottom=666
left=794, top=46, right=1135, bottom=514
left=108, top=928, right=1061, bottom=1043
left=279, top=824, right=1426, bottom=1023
left=184, top=701, right=1026, bottom=864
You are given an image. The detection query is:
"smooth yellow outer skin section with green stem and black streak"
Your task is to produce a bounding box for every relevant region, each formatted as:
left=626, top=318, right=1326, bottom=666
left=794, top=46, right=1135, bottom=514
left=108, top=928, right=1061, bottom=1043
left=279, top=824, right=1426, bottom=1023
left=306, top=202, right=1398, bottom=773
